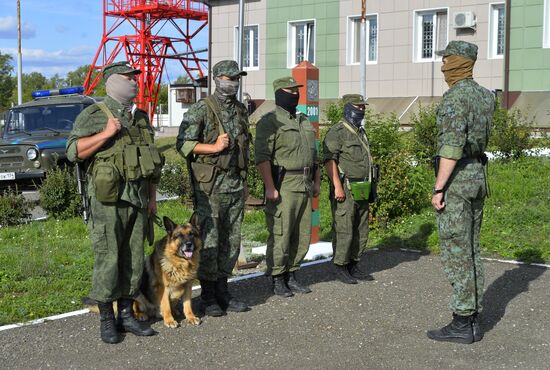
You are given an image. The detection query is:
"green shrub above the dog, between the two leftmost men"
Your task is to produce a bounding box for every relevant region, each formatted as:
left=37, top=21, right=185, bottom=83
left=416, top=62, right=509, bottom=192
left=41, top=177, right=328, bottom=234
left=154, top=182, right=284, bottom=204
left=158, top=158, right=191, bottom=201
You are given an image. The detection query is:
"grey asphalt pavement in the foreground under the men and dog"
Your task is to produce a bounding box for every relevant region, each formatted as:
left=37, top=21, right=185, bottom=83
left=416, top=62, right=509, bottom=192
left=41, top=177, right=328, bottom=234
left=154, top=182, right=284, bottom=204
left=0, top=250, right=550, bottom=369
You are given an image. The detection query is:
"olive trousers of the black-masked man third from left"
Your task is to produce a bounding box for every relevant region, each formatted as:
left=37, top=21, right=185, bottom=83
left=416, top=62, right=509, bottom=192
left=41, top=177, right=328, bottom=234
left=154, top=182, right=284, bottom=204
left=265, top=191, right=312, bottom=275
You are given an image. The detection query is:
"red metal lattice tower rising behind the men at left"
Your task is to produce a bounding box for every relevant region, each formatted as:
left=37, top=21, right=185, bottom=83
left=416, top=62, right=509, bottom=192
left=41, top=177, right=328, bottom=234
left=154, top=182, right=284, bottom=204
left=84, top=0, right=208, bottom=122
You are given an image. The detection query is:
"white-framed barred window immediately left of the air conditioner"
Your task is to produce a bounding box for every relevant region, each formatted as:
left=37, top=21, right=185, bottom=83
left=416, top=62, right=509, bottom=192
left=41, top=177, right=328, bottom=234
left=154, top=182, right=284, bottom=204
left=414, top=9, right=448, bottom=62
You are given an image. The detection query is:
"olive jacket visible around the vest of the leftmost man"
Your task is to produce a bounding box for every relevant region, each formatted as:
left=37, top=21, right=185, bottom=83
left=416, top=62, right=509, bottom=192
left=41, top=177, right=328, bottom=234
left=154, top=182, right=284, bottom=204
left=66, top=96, right=154, bottom=208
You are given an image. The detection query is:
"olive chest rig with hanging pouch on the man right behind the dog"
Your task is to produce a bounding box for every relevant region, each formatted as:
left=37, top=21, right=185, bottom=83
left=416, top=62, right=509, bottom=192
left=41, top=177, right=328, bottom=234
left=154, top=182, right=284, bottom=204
left=191, top=95, right=250, bottom=195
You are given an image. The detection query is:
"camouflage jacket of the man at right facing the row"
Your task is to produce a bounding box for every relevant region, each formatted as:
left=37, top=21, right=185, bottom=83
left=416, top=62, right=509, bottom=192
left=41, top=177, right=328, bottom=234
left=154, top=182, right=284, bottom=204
left=437, top=79, right=495, bottom=160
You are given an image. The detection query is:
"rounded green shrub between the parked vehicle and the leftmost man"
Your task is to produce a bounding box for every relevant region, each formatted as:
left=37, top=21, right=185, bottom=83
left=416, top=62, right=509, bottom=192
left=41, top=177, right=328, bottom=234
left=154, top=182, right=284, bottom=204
left=39, top=167, right=81, bottom=220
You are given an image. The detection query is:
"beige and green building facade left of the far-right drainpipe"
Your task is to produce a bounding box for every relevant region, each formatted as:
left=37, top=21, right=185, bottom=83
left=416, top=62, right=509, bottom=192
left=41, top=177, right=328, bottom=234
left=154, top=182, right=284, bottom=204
left=211, top=0, right=506, bottom=124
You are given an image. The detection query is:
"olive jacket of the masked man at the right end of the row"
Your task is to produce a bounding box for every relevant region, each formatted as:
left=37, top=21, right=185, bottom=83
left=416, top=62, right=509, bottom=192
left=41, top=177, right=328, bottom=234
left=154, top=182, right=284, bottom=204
left=323, top=122, right=371, bottom=179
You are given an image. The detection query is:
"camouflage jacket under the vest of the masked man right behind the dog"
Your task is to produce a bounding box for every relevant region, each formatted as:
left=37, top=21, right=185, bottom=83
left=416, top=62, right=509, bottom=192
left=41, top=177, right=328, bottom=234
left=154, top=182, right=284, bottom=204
left=176, top=93, right=250, bottom=193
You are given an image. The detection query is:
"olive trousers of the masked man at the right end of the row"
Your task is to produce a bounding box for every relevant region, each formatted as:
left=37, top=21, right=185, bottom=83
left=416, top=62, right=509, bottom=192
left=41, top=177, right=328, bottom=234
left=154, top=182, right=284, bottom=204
left=330, top=187, right=369, bottom=266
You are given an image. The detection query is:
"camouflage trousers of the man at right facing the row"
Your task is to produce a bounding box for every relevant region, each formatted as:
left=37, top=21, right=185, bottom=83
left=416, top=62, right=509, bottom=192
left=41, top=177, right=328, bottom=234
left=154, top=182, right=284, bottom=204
left=437, top=169, right=486, bottom=316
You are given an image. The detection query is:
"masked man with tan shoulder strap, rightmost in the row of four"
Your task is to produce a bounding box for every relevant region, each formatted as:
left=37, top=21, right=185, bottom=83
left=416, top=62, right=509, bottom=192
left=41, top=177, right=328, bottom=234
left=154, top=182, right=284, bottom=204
left=323, top=94, right=373, bottom=284
